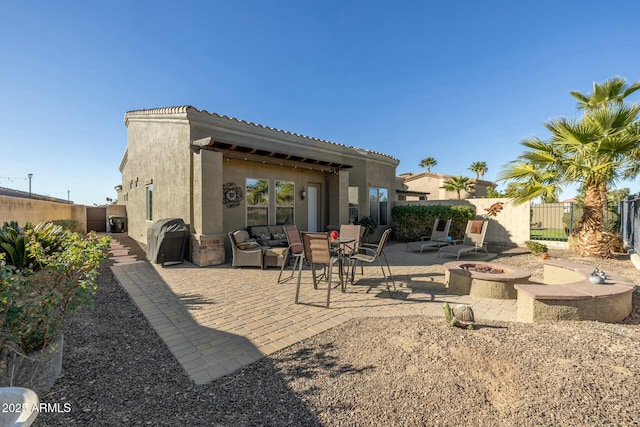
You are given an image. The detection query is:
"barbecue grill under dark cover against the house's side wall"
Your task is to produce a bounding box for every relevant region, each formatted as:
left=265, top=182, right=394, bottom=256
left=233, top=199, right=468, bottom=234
left=147, top=218, right=190, bottom=266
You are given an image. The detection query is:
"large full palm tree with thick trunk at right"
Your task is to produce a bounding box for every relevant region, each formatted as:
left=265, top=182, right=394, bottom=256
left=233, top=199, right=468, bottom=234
left=499, top=77, right=640, bottom=258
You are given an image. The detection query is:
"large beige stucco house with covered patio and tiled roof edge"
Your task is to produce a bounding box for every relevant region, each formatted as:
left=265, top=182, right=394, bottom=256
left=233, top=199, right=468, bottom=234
left=117, top=106, right=402, bottom=266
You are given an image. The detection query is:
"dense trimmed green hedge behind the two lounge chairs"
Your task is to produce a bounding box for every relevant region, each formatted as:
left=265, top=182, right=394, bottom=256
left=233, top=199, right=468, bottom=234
left=391, top=205, right=475, bottom=241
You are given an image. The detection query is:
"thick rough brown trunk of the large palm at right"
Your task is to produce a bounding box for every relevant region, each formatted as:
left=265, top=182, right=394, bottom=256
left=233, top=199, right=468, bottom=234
left=575, top=185, right=611, bottom=258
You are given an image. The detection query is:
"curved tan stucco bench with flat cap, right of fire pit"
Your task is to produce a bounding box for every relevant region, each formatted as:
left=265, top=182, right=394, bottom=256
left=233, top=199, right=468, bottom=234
left=515, top=260, right=635, bottom=322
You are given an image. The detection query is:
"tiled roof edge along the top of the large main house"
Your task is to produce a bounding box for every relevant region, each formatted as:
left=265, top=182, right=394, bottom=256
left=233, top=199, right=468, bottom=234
left=120, top=105, right=399, bottom=170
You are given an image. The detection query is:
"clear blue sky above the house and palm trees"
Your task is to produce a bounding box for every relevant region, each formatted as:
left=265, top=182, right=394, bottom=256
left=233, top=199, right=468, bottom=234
left=0, top=0, right=640, bottom=205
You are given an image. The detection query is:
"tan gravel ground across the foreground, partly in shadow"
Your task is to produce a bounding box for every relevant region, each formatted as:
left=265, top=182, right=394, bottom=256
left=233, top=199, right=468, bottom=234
left=34, top=235, right=640, bottom=426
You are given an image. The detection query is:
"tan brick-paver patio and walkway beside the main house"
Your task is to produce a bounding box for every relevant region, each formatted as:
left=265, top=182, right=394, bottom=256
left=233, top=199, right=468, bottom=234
left=111, top=236, right=516, bottom=384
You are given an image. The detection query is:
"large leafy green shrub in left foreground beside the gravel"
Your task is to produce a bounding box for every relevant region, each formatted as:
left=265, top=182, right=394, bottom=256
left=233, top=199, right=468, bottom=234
left=0, top=223, right=110, bottom=354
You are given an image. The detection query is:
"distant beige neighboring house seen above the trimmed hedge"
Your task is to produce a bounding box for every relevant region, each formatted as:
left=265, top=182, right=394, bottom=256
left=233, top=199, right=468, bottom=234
left=398, top=172, right=496, bottom=201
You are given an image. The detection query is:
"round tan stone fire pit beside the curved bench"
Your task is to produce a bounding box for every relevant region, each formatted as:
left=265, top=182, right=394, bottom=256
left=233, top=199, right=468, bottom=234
left=442, top=261, right=531, bottom=299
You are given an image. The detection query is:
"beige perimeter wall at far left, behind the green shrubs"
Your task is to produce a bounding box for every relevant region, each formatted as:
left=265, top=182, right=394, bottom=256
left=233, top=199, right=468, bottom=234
left=0, top=196, right=87, bottom=231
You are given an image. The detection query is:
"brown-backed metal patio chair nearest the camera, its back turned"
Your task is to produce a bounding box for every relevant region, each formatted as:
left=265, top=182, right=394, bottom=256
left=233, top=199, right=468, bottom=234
left=295, top=232, right=340, bottom=308
